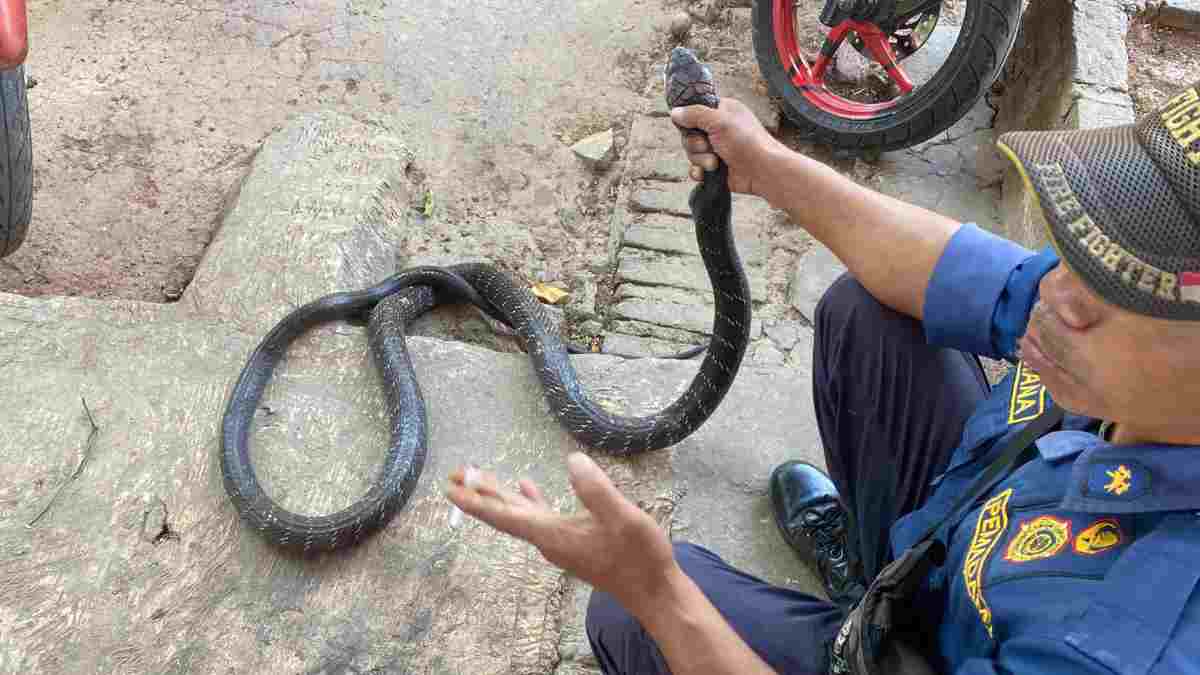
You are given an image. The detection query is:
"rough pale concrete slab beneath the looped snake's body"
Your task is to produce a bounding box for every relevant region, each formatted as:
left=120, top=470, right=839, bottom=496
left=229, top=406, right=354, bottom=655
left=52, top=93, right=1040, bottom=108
left=0, top=111, right=821, bottom=674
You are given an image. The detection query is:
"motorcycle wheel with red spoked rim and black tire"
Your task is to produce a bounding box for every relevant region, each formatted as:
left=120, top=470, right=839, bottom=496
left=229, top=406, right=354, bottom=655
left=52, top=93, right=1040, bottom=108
left=752, top=0, right=1021, bottom=151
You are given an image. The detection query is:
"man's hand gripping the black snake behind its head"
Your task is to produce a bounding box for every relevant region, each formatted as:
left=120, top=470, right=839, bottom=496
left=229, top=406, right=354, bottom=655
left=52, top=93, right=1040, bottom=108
left=671, top=98, right=786, bottom=197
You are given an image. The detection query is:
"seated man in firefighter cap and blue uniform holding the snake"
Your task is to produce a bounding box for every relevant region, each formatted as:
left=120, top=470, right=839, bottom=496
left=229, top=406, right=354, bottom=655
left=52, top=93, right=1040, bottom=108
left=449, top=79, right=1200, bottom=675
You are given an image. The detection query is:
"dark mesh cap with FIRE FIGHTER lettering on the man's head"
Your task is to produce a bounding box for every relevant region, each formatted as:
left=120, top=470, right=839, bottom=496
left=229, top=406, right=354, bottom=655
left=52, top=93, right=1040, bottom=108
left=997, top=82, right=1200, bottom=321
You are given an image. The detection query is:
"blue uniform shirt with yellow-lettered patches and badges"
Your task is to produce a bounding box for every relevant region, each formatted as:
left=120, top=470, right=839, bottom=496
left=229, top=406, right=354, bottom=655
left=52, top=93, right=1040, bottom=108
left=890, top=225, right=1200, bottom=675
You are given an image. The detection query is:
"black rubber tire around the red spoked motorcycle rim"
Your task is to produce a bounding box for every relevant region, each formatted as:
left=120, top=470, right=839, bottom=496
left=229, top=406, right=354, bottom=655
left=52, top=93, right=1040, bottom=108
left=752, top=0, right=1021, bottom=151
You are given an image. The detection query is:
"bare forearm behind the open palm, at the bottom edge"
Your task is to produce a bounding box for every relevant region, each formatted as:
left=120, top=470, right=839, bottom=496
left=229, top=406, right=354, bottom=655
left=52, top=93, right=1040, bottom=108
left=629, top=571, right=774, bottom=675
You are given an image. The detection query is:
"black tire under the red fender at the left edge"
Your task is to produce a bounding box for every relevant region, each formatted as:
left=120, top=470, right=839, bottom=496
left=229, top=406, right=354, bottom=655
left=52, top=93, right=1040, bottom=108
left=0, top=66, right=34, bottom=258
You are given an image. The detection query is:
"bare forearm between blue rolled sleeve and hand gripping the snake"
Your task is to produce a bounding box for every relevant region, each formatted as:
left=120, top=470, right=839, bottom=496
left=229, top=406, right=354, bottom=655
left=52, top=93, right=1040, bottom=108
left=755, top=145, right=960, bottom=318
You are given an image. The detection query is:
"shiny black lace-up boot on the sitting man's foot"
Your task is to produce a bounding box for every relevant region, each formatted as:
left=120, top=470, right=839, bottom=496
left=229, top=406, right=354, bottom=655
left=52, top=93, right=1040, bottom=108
left=770, top=461, right=866, bottom=609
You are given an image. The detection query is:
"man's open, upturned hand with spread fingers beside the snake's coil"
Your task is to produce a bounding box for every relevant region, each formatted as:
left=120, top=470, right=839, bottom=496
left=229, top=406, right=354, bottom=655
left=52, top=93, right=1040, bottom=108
left=446, top=453, right=682, bottom=614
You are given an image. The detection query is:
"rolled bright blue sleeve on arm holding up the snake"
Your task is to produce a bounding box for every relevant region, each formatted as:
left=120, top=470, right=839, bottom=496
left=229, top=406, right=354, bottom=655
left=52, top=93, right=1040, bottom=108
left=924, top=223, right=1058, bottom=358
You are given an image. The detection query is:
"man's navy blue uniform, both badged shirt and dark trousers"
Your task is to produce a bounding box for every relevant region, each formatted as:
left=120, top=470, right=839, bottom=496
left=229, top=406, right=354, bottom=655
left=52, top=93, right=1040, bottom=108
left=588, top=225, right=1200, bottom=675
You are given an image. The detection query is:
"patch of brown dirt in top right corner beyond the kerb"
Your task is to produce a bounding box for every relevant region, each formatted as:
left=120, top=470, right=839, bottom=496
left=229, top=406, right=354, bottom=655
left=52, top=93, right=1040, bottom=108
left=1126, top=14, right=1200, bottom=117
